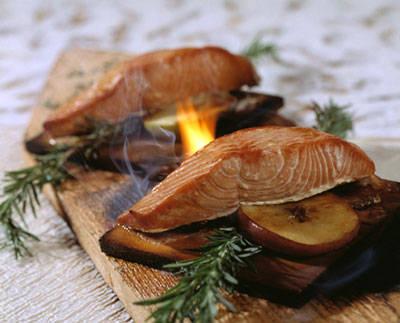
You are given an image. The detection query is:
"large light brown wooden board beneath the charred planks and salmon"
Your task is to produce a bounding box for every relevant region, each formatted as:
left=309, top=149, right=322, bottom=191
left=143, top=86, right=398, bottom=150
left=23, top=50, right=400, bottom=323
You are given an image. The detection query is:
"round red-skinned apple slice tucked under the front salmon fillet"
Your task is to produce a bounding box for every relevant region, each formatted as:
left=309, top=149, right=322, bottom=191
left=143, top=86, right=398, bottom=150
left=238, top=193, right=360, bottom=256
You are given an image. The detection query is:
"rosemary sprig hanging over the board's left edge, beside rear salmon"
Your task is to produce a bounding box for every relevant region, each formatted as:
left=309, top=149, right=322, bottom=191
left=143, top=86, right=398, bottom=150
left=0, top=122, right=121, bottom=258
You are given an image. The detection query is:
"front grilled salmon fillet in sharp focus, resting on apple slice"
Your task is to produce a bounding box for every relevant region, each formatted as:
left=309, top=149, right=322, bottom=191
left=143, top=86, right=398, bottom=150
left=118, top=127, right=375, bottom=232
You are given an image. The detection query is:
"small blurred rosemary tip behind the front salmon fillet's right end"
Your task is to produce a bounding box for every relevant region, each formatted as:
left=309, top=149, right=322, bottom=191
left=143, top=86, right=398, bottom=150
left=311, top=99, right=353, bottom=138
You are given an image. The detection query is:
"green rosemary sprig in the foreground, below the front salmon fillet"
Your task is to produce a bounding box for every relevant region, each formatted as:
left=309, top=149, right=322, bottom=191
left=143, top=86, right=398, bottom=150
left=136, top=228, right=261, bottom=323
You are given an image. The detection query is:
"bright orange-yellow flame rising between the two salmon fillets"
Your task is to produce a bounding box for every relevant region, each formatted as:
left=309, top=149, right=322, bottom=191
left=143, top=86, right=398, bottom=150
left=177, top=99, right=219, bottom=156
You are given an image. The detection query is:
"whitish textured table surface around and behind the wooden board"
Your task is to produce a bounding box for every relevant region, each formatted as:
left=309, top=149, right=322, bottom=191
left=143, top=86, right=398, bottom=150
left=0, top=0, right=400, bottom=322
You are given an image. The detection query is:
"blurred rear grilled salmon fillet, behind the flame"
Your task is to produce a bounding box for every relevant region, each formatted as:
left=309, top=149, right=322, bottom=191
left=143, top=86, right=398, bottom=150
left=44, top=47, right=259, bottom=137
